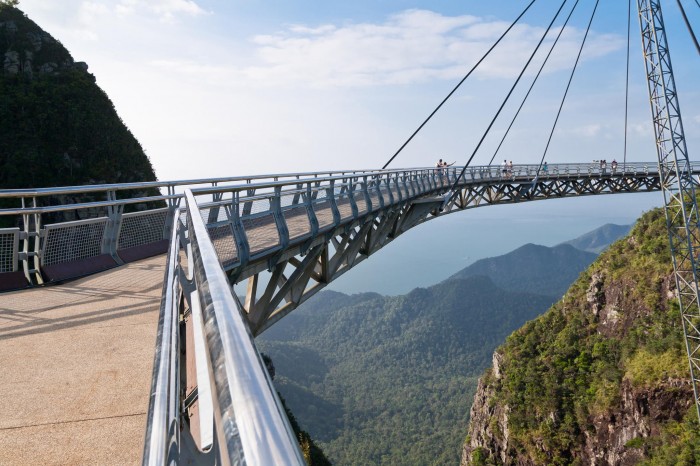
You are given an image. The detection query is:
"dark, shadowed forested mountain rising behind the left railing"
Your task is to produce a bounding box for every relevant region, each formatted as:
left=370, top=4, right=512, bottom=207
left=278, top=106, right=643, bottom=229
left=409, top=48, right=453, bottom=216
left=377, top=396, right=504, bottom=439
left=0, top=2, right=156, bottom=188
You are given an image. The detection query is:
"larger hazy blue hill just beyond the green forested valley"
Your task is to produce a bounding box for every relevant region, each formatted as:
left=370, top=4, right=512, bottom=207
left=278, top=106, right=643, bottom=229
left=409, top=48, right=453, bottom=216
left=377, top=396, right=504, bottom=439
left=448, top=244, right=596, bottom=298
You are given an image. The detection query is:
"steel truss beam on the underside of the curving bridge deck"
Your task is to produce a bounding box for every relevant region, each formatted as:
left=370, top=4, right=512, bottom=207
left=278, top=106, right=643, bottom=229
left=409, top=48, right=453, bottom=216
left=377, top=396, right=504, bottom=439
left=235, top=172, right=672, bottom=335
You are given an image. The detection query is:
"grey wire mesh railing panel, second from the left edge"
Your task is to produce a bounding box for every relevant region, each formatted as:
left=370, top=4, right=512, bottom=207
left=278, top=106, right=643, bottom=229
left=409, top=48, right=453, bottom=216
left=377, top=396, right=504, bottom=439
left=41, top=217, right=109, bottom=265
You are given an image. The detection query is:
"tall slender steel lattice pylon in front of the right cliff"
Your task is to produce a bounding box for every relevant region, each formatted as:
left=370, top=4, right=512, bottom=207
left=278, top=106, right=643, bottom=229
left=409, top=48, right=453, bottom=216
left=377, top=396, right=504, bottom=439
left=637, top=0, right=700, bottom=418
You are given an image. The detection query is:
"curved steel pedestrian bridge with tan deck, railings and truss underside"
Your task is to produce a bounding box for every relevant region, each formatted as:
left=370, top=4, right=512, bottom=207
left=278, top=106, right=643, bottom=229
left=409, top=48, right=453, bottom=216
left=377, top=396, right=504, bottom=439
left=0, top=163, right=700, bottom=464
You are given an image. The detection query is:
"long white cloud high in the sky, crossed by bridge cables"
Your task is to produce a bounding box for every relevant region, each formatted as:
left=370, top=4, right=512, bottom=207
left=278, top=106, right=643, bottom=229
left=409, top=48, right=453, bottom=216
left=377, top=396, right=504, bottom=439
left=239, top=10, right=623, bottom=87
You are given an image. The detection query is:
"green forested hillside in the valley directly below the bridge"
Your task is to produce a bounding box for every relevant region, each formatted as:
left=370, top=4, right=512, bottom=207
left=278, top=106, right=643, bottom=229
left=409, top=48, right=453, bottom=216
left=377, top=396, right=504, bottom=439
left=256, top=276, right=552, bottom=465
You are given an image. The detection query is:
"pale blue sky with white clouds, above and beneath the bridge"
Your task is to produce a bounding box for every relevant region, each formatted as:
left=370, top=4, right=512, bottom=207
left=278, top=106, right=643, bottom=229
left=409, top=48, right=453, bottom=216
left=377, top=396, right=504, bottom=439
left=19, top=0, right=700, bottom=292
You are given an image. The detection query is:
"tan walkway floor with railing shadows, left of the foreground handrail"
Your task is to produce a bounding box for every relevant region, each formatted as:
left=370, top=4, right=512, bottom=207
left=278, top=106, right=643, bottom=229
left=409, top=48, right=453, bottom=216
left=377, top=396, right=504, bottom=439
left=0, top=256, right=165, bottom=466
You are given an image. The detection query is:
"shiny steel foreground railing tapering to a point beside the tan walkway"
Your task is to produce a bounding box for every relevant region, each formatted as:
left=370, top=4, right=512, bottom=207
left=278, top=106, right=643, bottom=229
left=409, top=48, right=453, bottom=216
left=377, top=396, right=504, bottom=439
left=143, top=190, right=305, bottom=466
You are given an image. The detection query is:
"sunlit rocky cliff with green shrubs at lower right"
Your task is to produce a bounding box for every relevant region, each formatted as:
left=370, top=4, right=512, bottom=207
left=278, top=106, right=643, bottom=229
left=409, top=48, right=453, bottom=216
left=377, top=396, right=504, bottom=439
left=461, top=210, right=700, bottom=466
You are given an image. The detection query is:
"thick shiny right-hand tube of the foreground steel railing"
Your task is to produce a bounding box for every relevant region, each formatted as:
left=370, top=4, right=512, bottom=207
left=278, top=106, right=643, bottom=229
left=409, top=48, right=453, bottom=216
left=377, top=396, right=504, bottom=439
left=185, top=189, right=306, bottom=466
